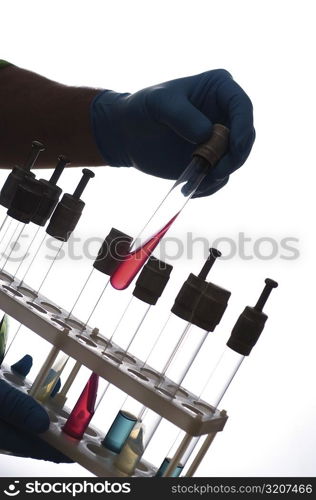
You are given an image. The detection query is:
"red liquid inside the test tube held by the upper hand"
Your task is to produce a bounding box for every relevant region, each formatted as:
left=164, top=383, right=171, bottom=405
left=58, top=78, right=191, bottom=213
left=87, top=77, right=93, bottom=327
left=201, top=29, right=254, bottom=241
left=110, top=213, right=179, bottom=290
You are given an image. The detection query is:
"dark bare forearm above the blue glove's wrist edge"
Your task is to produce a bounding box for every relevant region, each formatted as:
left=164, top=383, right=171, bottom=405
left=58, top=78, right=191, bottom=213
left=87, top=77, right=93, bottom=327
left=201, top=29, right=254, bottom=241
left=0, top=66, right=104, bottom=168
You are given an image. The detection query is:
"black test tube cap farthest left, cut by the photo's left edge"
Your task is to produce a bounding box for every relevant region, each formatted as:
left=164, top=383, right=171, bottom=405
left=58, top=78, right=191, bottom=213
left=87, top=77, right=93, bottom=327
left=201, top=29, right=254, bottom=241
left=0, top=141, right=45, bottom=208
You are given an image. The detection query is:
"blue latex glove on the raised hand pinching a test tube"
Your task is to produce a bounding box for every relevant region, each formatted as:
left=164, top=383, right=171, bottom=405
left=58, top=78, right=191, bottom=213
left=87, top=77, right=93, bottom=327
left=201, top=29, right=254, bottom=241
left=91, top=69, right=255, bottom=196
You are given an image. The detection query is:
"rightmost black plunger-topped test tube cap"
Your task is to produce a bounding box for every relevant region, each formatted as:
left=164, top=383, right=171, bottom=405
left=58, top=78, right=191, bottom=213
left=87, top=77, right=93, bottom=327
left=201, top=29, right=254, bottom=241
left=227, top=278, right=278, bottom=356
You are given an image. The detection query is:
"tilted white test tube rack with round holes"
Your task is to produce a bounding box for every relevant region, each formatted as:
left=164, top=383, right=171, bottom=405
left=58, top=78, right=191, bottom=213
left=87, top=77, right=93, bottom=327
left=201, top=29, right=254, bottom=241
left=0, top=271, right=228, bottom=477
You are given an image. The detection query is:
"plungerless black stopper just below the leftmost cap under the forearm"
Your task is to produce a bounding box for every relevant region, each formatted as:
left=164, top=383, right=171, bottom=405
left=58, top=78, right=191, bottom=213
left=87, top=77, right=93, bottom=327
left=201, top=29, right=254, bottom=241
left=7, top=177, right=43, bottom=224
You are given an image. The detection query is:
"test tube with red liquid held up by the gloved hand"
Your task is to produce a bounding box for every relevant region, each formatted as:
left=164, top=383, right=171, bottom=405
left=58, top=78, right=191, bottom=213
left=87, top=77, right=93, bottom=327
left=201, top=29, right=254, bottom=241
left=110, top=124, right=229, bottom=290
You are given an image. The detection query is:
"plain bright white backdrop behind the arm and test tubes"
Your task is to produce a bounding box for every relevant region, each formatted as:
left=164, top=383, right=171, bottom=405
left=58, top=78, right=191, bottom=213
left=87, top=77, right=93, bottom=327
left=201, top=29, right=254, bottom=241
left=0, top=0, right=316, bottom=476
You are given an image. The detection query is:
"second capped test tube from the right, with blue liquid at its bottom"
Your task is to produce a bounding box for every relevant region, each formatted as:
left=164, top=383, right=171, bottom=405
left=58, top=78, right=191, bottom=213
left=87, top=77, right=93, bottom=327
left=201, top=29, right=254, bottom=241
left=102, top=248, right=230, bottom=460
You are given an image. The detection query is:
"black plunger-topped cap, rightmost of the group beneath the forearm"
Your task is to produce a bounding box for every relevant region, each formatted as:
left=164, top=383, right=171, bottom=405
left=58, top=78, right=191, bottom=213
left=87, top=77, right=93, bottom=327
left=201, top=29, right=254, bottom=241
left=46, top=168, right=94, bottom=241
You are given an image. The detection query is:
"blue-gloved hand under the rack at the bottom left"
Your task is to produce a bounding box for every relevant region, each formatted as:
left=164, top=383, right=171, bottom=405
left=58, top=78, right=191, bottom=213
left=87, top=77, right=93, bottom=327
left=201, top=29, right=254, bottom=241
left=0, top=358, right=72, bottom=463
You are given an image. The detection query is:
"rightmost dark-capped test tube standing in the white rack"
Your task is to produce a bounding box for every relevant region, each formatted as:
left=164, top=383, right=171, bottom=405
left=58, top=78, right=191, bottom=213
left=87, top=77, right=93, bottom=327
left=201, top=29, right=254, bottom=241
left=153, top=278, right=278, bottom=476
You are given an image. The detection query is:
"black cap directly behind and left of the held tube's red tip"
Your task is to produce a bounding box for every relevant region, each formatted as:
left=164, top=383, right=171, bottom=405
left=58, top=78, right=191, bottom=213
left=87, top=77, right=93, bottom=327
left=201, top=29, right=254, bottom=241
left=93, top=227, right=133, bottom=276
